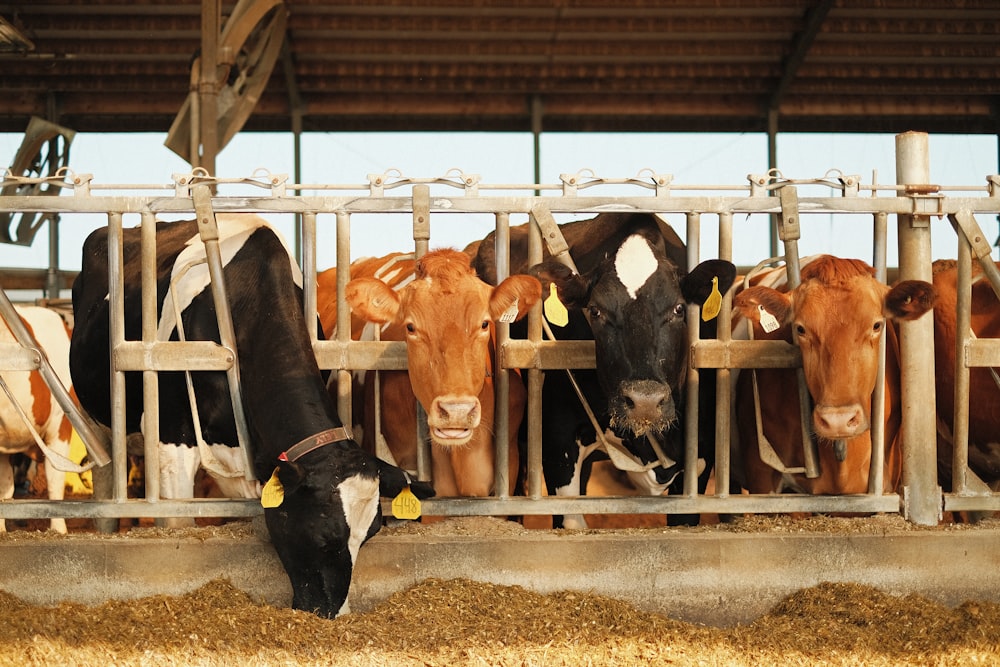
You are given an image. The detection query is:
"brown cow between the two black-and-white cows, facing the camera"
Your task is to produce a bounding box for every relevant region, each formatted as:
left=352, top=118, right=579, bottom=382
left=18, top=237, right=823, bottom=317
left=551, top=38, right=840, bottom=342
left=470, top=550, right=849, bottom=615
left=318, top=249, right=541, bottom=497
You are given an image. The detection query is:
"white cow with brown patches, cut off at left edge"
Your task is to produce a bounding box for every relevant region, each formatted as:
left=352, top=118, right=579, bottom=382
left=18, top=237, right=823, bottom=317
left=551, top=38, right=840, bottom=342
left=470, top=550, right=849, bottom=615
left=0, top=306, right=73, bottom=533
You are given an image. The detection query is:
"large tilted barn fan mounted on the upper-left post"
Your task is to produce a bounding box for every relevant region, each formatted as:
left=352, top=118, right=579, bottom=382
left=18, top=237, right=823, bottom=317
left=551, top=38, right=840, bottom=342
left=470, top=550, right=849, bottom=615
left=164, top=0, right=288, bottom=165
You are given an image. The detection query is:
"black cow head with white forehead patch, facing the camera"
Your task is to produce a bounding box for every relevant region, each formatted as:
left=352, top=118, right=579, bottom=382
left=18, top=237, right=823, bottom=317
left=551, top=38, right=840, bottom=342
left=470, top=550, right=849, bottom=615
left=532, top=233, right=736, bottom=436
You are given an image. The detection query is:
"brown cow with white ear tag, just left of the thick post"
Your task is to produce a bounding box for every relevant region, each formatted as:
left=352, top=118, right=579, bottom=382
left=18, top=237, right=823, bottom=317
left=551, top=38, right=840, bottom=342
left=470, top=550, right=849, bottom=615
left=733, top=255, right=934, bottom=494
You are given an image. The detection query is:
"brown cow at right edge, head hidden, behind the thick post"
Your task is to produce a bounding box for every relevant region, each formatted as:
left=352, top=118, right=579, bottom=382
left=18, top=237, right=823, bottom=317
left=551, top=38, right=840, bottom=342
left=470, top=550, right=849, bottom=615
left=934, top=260, right=1000, bottom=489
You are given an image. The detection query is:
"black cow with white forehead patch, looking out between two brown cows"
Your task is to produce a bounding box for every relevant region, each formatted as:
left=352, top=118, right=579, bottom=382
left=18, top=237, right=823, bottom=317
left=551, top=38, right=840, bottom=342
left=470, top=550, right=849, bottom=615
left=473, top=213, right=736, bottom=527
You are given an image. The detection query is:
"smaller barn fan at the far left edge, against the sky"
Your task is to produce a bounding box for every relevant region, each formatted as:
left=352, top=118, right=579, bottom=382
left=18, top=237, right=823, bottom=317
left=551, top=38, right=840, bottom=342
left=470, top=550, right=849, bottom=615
left=0, top=116, right=76, bottom=246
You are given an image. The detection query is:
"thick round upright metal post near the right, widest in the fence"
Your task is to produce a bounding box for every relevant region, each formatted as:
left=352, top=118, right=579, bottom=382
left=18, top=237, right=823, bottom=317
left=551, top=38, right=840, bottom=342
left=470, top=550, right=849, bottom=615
left=896, top=132, right=941, bottom=526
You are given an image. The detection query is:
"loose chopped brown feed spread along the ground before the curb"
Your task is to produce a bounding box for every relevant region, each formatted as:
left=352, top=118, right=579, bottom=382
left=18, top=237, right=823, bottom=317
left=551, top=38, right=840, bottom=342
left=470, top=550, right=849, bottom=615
left=0, top=519, right=1000, bottom=667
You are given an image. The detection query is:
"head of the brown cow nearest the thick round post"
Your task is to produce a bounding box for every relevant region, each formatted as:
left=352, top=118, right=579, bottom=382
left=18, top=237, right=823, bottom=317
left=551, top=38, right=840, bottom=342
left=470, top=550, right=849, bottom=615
left=733, top=255, right=935, bottom=440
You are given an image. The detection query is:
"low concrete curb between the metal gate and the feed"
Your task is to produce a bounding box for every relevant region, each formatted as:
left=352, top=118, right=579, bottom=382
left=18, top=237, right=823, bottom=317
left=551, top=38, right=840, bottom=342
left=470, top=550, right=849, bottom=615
left=0, top=529, right=1000, bottom=626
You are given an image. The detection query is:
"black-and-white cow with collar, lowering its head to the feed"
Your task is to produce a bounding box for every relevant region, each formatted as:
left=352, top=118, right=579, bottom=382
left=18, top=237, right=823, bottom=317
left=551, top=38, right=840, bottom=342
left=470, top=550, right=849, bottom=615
left=70, top=215, right=432, bottom=617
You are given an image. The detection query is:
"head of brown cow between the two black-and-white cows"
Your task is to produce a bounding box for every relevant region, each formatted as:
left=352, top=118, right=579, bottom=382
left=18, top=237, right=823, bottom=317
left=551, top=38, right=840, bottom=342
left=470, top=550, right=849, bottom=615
left=346, top=250, right=541, bottom=446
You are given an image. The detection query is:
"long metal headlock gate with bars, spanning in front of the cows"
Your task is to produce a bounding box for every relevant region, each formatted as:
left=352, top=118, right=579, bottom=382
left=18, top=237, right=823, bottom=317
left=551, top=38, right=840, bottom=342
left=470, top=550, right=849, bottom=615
left=0, top=133, right=1000, bottom=525
